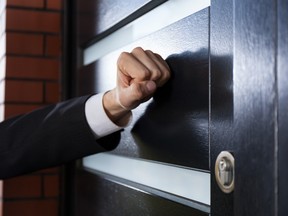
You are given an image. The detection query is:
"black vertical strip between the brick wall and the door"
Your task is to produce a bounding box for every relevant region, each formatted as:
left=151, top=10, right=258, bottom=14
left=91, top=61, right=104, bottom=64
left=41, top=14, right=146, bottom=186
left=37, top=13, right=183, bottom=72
left=59, top=0, right=77, bottom=216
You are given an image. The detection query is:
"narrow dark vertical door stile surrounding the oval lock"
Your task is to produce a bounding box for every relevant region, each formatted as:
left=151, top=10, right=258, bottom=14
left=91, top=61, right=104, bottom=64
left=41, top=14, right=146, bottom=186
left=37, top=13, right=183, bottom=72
left=210, top=0, right=234, bottom=216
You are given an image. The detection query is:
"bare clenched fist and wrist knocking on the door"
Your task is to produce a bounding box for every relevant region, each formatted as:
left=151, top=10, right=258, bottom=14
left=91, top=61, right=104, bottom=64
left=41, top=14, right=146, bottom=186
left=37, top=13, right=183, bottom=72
left=103, top=47, right=170, bottom=125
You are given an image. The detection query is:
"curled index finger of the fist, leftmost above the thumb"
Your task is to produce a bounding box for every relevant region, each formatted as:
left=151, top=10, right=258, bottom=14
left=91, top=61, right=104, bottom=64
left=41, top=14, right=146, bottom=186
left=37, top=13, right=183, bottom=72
left=117, top=52, right=150, bottom=84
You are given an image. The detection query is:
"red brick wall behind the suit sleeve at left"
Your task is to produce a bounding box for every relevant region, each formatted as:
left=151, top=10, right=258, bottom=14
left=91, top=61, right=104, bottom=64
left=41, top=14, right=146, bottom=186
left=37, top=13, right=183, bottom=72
left=0, top=0, right=62, bottom=216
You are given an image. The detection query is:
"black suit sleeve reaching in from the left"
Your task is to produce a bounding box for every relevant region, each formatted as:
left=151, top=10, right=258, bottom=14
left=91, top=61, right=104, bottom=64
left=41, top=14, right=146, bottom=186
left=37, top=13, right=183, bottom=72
left=0, top=96, right=119, bottom=179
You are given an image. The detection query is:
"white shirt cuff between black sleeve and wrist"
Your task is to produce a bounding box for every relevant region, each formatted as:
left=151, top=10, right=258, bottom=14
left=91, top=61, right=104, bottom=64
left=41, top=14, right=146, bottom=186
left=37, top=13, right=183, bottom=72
left=85, top=93, right=126, bottom=138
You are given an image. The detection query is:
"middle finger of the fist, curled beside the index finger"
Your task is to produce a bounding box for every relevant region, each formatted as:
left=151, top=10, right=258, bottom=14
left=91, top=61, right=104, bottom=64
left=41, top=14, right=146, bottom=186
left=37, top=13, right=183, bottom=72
left=131, top=47, right=162, bottom=83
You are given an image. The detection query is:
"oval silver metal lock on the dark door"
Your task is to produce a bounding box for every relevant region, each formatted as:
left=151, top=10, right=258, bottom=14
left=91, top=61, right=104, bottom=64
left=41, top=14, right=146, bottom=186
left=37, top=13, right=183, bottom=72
left=215, top=151, right=235, bottom=193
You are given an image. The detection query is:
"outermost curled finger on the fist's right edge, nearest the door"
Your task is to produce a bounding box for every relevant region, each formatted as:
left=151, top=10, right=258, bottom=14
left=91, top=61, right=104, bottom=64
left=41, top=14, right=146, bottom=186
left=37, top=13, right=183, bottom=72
left=145, top=50, right=171, bottom=86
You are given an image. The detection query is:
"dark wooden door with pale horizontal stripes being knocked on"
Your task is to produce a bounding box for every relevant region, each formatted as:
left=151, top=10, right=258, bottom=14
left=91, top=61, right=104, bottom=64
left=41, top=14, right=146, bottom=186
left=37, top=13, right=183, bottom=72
left=66, top=0, right=288, bottom=216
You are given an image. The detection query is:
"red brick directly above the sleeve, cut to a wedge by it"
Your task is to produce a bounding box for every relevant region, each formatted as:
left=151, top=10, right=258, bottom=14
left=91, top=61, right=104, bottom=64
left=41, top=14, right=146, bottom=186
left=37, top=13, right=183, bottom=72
left=5, top=103, right=41, bottom=118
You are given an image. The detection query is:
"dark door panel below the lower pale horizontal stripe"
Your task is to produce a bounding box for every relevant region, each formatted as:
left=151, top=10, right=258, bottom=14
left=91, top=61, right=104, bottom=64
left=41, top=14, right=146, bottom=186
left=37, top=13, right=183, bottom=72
left=76, top=171, right=209, bottom=216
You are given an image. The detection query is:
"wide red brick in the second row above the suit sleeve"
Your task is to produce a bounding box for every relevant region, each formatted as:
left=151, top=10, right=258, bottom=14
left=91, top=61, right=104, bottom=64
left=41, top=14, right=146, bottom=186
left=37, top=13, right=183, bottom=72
left=5, top=80, right=43, bottom=103
